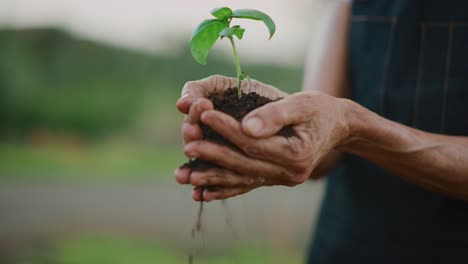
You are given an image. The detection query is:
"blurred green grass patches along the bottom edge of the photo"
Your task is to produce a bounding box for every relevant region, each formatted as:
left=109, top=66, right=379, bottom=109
left=15, top=236, right=301, bottom=264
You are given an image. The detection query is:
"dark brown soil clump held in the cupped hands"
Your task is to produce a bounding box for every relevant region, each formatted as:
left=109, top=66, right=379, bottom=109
left=181, top=88, right=296, bottom=171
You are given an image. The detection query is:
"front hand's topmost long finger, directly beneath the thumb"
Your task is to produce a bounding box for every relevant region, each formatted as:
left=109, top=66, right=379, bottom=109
left=201, top=110, right=301, bottom=164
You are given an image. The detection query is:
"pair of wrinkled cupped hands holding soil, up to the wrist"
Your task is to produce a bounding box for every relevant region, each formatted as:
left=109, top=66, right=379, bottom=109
left=176, top=74, right=350, bottom=201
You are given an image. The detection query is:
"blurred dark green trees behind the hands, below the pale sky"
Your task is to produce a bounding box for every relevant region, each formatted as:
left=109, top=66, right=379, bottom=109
left=0, top=29, right=301, bottom=139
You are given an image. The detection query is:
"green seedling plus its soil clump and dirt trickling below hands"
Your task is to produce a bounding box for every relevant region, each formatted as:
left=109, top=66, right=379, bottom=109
left=186, top=11, right=288, bottom=263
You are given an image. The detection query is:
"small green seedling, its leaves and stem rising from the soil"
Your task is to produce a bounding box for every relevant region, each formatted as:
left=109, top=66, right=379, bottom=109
left=190, top=7, right=276, bottom=98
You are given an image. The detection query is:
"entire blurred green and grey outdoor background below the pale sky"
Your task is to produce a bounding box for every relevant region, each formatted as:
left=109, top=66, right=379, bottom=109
left=0, top=1, right=321, bottom=264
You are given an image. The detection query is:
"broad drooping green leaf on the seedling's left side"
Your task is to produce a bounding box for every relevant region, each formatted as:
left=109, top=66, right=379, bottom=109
left=190, top=19, right=227, bottom=65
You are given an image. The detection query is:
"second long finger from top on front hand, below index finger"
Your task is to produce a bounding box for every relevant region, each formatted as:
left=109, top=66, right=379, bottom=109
left=184, top=140, right=284, bottom=177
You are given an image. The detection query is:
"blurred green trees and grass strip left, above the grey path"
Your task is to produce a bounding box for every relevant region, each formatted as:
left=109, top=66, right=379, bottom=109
left=0, top=29, right=302, bottom=182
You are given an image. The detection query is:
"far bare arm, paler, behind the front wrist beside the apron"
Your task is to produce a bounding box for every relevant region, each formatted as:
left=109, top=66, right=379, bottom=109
left=303, top=1, right=351, bottom=179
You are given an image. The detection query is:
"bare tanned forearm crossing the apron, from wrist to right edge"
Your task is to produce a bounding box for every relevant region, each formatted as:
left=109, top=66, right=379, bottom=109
left=340, top=100, right=468, bottom=200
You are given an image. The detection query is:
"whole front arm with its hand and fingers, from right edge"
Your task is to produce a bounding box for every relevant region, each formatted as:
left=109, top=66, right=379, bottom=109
left=184, top=91, right=468, bottom=201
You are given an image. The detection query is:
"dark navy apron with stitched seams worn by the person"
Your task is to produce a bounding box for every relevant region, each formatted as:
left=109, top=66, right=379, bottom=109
left=308, top=0, right=468, bottom=264
